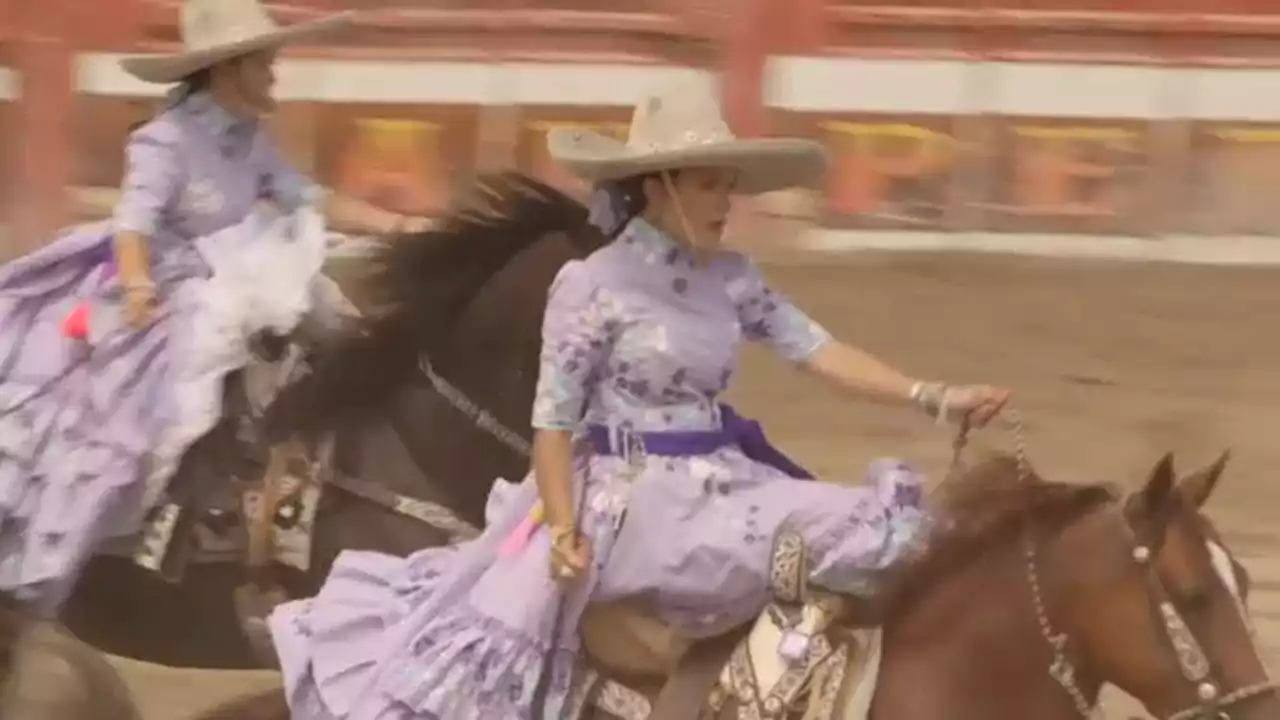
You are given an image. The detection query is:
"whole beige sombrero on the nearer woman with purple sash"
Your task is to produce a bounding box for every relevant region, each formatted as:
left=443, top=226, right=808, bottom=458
left=547, top=83, right=827, bottom=195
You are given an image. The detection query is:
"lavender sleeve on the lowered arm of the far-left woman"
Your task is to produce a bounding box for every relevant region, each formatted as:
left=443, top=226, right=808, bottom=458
left=114, top=120, right=183, bottom=237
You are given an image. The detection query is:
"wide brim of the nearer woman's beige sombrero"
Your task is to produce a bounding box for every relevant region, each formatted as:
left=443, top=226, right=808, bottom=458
left=547, top=128, right=827, bottom=195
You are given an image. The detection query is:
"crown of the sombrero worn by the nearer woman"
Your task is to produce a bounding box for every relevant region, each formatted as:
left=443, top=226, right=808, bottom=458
left=627, top=83, right=737, bottom=155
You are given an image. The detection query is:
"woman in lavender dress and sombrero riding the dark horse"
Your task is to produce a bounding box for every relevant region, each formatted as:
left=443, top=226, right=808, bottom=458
left=0, top=0, right=435, bottom=612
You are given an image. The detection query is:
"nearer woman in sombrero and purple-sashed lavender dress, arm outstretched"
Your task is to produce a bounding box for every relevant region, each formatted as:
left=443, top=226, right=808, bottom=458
left=271, top=81, right=1007, bottom=720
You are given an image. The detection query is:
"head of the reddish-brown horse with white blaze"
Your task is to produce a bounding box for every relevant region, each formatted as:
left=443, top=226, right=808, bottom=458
left=1062, top=454, right=1280, bottom=720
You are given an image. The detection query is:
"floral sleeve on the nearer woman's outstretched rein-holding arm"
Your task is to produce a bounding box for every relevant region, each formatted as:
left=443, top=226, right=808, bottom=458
left=728, top=255, right=831, bottom=363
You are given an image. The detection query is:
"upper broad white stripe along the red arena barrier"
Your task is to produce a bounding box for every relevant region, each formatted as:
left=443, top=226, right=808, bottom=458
left=0, top=53, right=1280, bottom=120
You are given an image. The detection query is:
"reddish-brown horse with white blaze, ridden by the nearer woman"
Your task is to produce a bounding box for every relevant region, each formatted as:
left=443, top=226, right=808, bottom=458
left=72, top=448, right=1259, bottom=720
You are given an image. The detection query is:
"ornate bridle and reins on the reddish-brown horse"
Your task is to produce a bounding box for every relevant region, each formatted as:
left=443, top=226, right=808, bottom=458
left=952, top=410, right=1280, bottom=720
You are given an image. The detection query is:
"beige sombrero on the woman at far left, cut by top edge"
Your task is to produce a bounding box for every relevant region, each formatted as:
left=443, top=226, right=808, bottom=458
left=120, top=0, right=356, bottom=83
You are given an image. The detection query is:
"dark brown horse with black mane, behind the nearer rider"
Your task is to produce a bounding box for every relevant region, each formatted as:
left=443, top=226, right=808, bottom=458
left=49, top=174, right=604, bottom=667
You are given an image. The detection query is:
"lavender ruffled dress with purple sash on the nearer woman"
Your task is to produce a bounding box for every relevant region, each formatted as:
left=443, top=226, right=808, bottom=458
left=271, top=219, right=927, bottom=720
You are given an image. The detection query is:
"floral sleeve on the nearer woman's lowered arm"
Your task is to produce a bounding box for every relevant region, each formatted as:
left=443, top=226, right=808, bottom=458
left=532, top=260, right=618, bottom=430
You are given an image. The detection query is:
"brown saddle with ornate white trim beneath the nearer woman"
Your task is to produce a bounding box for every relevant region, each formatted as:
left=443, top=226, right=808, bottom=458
left=581, top=529, right=878, bottom=720
